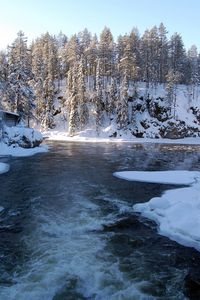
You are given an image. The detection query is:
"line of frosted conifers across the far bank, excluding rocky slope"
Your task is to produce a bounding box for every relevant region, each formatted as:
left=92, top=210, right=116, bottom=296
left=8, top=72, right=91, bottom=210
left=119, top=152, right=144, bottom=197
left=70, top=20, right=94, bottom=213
left=0, top=23, right=200, bottom=135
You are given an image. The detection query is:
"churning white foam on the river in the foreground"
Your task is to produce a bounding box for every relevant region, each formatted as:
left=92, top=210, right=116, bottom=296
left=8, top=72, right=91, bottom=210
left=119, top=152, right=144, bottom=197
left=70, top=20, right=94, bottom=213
left=0, top=191, right=148, bottom=300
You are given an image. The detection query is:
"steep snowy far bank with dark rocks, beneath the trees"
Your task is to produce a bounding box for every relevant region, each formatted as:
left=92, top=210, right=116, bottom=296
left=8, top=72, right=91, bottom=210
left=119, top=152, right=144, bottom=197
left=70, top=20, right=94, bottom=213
left=42, top=82, right=200, bottom=142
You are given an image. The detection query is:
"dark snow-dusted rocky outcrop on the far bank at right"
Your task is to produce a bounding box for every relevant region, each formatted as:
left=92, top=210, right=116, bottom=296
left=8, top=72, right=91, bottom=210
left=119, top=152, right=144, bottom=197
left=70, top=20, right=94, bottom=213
left=129, top=97, right=200, bottom=139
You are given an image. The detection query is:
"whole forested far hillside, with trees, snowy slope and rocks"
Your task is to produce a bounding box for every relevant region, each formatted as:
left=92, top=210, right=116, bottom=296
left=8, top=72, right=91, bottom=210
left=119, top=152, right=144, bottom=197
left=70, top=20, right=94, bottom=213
left=0, top=23, right=200, bottom=138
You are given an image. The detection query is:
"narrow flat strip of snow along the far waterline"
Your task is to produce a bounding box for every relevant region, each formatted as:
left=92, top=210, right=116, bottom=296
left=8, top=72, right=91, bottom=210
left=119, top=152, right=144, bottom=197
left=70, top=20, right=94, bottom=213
left=43, top=130, right=200, bottom=145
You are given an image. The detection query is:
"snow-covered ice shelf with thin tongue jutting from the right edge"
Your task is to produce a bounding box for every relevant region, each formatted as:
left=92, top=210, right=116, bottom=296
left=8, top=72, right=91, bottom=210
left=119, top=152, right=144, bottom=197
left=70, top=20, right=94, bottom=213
left=114, top=171, right=200, bottom=251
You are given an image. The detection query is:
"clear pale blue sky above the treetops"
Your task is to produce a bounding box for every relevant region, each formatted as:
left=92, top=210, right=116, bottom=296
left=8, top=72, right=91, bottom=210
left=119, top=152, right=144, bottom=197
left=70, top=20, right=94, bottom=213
left=0, top=0, right=200, bottom=51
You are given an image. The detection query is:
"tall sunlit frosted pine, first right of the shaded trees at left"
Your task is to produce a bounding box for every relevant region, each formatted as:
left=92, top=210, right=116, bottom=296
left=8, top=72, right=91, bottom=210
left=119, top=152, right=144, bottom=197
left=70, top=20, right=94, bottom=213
left=32, top=32, right=60, bottom=129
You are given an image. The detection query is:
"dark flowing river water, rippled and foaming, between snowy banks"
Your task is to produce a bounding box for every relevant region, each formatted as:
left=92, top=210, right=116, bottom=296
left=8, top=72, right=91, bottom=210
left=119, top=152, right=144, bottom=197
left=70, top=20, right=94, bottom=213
left=0, top=143, right=200, bottom=300
